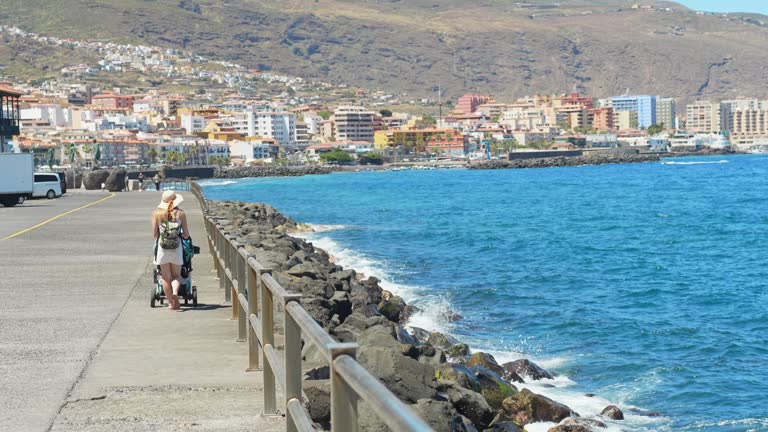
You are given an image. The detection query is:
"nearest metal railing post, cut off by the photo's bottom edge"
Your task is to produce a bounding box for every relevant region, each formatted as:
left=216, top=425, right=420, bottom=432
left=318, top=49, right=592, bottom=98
left=328, top=343, right=358, bottom=432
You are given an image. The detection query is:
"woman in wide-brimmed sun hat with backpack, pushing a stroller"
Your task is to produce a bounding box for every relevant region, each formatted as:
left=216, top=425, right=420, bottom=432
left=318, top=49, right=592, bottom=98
left=152, top=190, right=189, bottom=310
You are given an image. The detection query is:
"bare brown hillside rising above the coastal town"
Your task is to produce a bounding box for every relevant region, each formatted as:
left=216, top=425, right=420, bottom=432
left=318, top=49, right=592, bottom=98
left=0, top=0, right=768, bottom=99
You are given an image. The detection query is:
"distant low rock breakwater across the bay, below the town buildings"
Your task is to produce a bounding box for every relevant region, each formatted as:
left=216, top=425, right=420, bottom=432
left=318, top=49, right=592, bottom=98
left=469, top=154, right=661, bottom=169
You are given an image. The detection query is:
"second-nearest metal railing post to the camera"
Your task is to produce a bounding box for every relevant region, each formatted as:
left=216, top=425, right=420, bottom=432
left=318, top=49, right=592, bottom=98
left=283, top=294, right=301, bottom=432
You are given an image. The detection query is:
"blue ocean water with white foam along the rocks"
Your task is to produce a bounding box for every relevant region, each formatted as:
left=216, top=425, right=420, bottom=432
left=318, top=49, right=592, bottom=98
left=204, top=156, right=768, bottom=432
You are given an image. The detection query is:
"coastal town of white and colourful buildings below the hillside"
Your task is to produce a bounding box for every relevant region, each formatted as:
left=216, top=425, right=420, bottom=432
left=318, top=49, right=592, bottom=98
left=0, top=27, right=768, bottom=168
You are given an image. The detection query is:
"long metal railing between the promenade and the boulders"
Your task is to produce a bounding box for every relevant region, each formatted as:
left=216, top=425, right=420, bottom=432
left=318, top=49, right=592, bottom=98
left=191, top=182, right=433, bottom=432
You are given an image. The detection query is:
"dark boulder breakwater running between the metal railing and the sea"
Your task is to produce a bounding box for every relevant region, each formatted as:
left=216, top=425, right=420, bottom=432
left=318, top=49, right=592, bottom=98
left=209, top=201, right=618, bottom=432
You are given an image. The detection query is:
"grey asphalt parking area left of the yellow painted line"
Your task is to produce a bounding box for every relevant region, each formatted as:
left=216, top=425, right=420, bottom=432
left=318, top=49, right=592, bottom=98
left=0, top=190, right=120, bottom=239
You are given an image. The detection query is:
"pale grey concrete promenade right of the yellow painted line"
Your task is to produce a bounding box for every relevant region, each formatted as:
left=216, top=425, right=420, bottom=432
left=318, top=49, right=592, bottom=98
left=0, top=191, right=284, bottom=432
